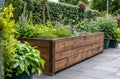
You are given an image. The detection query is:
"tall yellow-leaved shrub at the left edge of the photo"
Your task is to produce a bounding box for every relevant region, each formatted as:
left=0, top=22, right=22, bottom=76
left=0, top=5, right=15, bottom=76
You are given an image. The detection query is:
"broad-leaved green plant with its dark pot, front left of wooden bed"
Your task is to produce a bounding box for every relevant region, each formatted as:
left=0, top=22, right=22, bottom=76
left=4, top=40, right=44, bottom=79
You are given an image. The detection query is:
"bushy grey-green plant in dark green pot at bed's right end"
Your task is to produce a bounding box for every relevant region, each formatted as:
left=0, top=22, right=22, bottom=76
left=96, top=15, right=117, bottom=49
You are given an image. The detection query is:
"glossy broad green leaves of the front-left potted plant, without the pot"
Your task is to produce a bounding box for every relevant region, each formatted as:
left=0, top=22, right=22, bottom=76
left=10, top=41, right=45, bottom=75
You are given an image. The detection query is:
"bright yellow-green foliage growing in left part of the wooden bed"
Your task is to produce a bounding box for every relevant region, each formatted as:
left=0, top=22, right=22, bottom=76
left=14, top=24, right=75, bottom=39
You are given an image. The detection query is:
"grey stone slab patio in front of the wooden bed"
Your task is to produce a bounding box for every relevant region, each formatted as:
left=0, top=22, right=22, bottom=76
left=34, top=44, right=120, bottom=79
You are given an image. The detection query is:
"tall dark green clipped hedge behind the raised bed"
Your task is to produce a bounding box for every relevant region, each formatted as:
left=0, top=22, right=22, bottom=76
left=6, top=0, right=84, bottom=23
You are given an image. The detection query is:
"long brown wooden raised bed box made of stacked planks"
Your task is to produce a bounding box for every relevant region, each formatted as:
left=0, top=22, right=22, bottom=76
left=20, top=33, right=104, bottom=75
